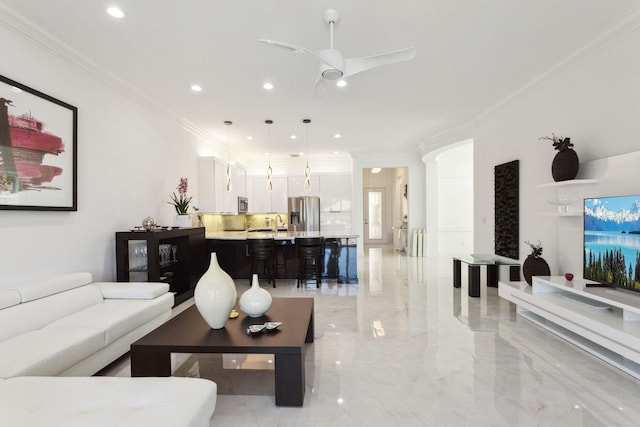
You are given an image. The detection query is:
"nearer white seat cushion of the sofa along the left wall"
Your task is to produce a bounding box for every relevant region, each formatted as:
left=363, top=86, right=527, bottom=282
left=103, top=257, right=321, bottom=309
left=0, top=327, right=104, bottom=378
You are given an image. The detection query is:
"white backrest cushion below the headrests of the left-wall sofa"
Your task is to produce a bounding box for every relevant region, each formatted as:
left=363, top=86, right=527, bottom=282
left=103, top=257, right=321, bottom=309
left=0, top=285, right=103, bottom=341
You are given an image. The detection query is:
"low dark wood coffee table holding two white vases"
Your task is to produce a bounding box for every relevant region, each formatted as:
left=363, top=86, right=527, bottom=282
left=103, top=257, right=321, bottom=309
left=131, top=298, right=314, bottom=406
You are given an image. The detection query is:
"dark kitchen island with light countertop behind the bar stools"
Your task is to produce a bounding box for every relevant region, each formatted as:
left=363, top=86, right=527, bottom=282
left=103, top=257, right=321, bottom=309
left=206, top=231, right=358, bottom=283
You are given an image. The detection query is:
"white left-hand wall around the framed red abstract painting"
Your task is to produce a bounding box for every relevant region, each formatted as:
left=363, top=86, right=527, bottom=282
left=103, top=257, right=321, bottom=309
left=0, top=20, right=215, bottom=287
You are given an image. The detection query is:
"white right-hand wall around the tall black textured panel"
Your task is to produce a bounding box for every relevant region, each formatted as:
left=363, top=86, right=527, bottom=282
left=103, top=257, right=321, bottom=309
left=424, top=16, right=640, bottom=274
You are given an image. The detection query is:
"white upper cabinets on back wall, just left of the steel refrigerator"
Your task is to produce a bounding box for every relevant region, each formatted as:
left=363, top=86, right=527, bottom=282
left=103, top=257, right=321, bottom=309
left=247, top=176, right=287, bottom=213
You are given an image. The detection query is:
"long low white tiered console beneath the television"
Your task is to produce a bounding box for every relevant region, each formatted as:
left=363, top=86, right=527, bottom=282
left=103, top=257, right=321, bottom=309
left=498, top=276, right=640, bottom=379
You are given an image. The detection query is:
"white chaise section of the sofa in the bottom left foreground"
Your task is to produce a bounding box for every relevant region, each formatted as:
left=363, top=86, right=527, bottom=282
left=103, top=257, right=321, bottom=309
left=0, top=377, right=217, bottom=427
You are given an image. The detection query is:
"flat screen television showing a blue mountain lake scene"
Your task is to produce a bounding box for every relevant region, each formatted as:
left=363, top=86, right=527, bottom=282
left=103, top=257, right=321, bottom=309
left=583, top=196, right=640, bottom=292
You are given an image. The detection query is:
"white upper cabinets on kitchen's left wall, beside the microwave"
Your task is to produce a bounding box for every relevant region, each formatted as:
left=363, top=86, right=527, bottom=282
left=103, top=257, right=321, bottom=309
left=198, top=157, right=247, bottom=213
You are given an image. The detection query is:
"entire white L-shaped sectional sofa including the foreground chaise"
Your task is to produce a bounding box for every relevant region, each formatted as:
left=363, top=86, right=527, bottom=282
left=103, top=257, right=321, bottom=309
left=0, top=273, right=217, bottom=427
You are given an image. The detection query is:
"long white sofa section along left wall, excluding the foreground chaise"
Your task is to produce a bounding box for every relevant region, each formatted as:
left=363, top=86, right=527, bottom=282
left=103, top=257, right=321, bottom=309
left=0, top=273, right=173, bottom=378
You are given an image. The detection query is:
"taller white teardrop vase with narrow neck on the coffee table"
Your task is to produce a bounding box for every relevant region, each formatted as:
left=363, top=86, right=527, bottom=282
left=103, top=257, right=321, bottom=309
left=193, top=252, right=238, bottom=329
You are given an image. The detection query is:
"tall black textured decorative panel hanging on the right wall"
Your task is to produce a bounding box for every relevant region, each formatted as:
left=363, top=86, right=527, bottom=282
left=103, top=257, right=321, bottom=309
left=493, top=160, right=520, bottom=259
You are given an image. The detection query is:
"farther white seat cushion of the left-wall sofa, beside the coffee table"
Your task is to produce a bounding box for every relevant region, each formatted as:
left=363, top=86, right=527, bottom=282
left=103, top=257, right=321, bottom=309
left=45, top=294, right=173, bottom=345
